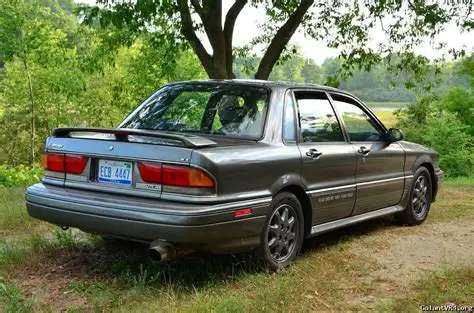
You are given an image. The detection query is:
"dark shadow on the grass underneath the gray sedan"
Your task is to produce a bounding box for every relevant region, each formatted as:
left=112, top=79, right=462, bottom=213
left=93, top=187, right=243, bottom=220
left=10, top=214, right=395, bottom=291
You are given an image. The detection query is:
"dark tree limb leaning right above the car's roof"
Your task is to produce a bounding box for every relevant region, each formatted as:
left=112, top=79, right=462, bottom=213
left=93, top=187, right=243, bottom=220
left=255, top=0, right=314, bottom=79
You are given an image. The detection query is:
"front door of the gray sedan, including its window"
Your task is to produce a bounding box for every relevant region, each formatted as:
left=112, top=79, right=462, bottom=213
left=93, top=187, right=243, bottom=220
left=330, top=93, right=405, bottom=215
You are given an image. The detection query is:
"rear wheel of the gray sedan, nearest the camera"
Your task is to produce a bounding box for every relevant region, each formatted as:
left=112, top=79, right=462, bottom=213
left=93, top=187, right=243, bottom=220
left=259, top=192, right=304, bottom=271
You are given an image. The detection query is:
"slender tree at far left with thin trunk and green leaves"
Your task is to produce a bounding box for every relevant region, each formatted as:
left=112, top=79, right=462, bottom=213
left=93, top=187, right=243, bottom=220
left=0, top=0, right=77, bottom=164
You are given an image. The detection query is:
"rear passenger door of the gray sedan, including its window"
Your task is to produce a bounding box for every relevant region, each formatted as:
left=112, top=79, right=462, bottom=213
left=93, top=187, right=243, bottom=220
left=293, top=90, right=356, bottom=225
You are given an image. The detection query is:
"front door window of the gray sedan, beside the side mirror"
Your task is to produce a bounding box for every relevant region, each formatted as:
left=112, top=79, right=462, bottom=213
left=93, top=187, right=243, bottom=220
left=331, top=94, right=382, bottom=141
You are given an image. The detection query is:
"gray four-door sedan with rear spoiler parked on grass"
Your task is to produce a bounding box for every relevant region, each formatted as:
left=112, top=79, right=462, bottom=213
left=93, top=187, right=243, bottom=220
left=26, top=80, right=443, bottom=269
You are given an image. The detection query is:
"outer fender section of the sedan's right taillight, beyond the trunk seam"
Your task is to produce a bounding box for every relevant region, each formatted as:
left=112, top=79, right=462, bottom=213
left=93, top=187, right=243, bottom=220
left=163, top=165, right=214, bottom=188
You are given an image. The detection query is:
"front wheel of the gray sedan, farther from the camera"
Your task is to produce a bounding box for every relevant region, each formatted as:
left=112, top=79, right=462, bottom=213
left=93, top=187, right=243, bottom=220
left=395, top=166, right=433, bottom=226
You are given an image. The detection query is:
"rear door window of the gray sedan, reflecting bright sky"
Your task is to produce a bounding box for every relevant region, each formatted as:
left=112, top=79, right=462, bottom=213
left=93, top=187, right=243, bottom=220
left=295, top=91, right=344, bottom=142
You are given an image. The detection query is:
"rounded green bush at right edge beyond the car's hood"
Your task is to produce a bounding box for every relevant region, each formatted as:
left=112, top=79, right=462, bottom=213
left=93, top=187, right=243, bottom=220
left=397, top=87, right=474, bottom=177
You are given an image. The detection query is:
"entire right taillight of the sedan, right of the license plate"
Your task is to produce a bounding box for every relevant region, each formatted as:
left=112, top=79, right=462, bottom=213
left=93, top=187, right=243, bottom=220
left=138, top=162, right=215, bottom=188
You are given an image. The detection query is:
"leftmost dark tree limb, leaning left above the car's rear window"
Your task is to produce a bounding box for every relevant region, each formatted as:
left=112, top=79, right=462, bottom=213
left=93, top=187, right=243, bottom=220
left=176, top=0, right=214, bottom=77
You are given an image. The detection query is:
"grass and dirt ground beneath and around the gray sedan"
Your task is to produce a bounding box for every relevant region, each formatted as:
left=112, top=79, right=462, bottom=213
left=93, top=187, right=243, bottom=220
left=0, top=179, right=474, bottom=312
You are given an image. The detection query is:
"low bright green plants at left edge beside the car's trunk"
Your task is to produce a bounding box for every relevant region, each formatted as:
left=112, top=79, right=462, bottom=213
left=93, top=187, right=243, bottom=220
left=0, top=165, right=43, bottom=187
